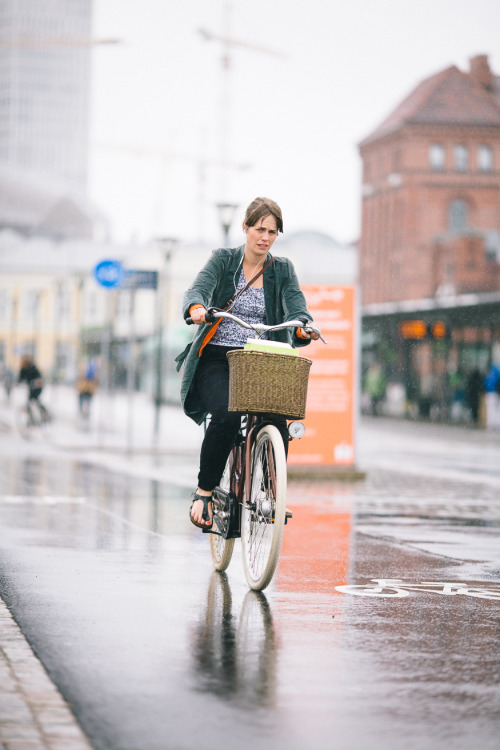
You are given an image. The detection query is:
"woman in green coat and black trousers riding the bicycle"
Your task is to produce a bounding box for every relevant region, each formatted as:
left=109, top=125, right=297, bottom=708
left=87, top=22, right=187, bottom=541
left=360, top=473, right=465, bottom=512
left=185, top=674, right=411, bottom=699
left=177, top=198, right=318, bottom=529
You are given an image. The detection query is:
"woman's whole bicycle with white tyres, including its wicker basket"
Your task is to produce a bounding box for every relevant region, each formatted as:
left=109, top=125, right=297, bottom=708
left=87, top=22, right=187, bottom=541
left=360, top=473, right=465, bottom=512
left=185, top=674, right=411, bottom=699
left=187, top=308, right=326, bottom=591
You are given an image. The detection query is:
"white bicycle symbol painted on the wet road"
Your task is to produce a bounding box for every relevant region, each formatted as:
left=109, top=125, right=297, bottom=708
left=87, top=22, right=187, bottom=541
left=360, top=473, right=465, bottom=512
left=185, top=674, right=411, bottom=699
left=335, top=578, right=500, bottom=601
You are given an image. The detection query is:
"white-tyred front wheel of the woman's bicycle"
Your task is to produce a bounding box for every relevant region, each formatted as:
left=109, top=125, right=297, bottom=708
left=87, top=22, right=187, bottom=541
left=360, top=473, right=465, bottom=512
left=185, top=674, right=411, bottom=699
left=241, top=425, right=286, bottom=591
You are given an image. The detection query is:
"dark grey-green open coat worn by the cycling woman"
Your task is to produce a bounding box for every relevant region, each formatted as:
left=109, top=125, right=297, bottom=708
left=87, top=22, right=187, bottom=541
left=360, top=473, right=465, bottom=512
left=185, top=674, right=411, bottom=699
left=176, top=245, right=312, bottom=424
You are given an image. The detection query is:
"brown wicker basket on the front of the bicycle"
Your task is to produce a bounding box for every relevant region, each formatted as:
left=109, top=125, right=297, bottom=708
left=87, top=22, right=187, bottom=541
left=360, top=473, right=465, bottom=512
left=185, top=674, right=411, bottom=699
left=227, top=349, right=312, bottom=419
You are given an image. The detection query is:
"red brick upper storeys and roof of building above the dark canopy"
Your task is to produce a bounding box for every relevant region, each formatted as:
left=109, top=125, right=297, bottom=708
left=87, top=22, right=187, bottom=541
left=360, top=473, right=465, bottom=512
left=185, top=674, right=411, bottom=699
left=360, top=56, right=500, bottom=304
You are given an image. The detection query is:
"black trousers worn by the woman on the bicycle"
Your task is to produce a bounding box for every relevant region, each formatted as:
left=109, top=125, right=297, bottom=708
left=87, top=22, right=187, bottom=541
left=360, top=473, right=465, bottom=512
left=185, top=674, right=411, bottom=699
left=195, top=344, right=288, bottom=492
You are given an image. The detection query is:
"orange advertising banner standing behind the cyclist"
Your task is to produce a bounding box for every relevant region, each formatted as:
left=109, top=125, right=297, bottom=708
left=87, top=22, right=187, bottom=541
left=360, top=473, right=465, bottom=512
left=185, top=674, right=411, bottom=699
left=288, top=285, right=358, bottom=467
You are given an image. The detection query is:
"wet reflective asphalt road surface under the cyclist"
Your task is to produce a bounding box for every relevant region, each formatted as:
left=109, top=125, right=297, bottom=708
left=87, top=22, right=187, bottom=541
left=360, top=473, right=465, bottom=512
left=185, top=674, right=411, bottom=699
left=0, top=420, right=500, bottom=750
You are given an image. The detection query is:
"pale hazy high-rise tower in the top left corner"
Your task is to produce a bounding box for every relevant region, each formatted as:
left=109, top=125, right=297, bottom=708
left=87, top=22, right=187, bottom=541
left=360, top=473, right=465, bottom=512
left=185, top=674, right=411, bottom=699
left=0, top=0, right=92, bottom=191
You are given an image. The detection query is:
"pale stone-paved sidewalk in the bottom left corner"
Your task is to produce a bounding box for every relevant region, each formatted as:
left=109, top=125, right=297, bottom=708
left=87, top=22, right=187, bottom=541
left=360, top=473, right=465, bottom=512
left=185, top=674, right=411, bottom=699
left=0, top=598, right=92, bottom=750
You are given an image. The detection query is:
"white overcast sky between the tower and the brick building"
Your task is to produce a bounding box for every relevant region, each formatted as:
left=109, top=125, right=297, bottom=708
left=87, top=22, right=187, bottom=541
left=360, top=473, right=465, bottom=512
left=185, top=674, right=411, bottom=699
left=91, top=0, right=500, bottom=244
